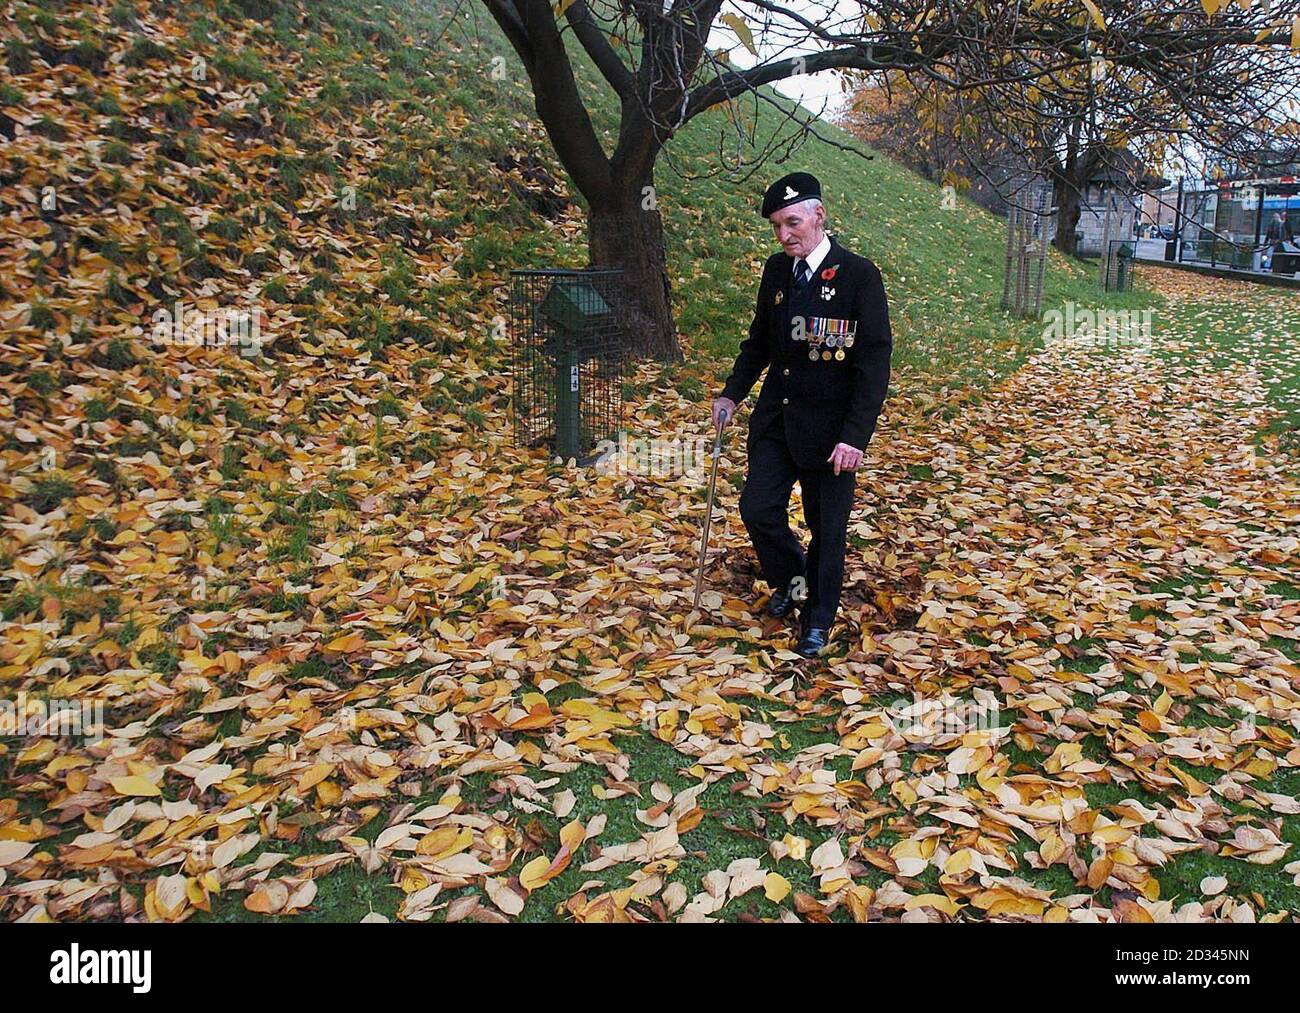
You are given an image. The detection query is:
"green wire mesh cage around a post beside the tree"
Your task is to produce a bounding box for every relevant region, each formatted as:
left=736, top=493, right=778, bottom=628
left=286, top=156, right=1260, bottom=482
left=510, top=268, right=628, bottom=464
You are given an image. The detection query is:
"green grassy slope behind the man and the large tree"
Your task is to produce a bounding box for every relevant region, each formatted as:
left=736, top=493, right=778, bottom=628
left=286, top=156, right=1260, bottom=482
left=4, top=0, right=1151, bottom=403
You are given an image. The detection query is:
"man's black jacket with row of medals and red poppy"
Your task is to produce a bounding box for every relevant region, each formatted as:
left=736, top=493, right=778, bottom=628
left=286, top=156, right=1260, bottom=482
left=723, top=238, right=893, bottom=469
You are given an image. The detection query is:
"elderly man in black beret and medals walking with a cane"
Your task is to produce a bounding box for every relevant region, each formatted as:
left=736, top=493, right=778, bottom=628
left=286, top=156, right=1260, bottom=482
left=712, top=173, right=893, bottom=658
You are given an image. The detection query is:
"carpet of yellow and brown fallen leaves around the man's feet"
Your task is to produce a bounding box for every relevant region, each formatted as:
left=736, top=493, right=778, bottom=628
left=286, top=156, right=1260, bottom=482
left=0, top=250, right=1300, bottom=921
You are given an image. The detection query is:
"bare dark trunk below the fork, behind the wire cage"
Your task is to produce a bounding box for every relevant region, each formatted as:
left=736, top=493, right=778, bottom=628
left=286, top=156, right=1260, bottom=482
left=586, top=201, right=683, bottom=362
